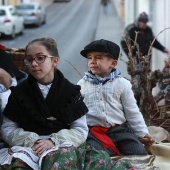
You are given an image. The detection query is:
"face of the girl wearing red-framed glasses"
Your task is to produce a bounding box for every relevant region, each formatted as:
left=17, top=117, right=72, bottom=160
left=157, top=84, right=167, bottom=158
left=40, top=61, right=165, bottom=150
left=26, top=43, right=59, bottom=83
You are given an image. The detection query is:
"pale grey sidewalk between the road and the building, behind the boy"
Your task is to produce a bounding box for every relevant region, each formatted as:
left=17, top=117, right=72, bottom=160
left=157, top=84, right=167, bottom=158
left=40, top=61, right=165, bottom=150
left=95, top=1, right=130, bottom=80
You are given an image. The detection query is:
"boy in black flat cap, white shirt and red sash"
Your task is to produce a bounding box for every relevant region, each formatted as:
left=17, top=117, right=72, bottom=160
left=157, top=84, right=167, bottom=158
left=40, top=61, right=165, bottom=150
left=78, top=39, right=154, bottom=156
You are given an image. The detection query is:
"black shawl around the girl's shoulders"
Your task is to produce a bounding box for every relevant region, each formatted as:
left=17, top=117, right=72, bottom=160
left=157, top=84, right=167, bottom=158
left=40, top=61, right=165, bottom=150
left=3, top=70, right=88, bottom=135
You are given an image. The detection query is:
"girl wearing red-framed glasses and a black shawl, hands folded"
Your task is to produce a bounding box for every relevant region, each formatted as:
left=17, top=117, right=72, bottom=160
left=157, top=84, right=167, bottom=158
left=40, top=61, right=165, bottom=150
left=0, top=37, right=88, bottom=169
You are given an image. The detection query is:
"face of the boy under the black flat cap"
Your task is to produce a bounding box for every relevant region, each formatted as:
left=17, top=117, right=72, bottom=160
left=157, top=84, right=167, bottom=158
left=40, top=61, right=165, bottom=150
left=87, top=52, right=117, bottom=78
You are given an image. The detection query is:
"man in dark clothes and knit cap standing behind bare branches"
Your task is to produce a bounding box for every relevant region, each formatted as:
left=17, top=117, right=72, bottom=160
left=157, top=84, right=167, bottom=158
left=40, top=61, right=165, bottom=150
left=121, top=12, right=170, bottom=105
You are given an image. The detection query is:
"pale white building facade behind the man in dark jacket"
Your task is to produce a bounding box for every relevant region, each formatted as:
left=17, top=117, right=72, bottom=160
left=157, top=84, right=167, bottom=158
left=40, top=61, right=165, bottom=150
left=113, top=0, right=170, bottom=70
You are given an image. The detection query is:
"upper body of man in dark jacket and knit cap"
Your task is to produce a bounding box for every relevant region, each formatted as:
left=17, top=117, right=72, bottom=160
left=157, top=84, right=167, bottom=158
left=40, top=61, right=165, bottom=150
left=121, top=12, right=170, bottom=63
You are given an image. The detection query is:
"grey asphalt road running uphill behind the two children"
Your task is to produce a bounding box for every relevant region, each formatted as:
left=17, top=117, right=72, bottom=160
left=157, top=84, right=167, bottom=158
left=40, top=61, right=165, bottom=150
left=1, top=0, right=100, bottom=83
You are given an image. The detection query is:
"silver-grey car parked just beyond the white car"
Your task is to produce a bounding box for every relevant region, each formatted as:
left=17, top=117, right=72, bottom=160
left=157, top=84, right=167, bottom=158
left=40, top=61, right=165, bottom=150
left=15, top=2, right=46, bottom=26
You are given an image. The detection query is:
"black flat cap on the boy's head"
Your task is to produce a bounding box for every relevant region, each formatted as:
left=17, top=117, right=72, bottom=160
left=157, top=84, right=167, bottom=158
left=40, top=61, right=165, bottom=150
left=80, top=39, right=120, bottom=60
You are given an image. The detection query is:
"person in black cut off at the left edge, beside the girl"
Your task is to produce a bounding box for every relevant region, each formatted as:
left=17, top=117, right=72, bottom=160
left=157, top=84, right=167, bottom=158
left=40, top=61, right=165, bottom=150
left=0, top=44, right=27, bottom=127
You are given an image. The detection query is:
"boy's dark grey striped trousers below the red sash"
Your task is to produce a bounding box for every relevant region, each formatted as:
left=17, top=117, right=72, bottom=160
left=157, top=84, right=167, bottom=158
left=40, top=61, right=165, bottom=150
left=86, top=123, right=147, bottom=156
